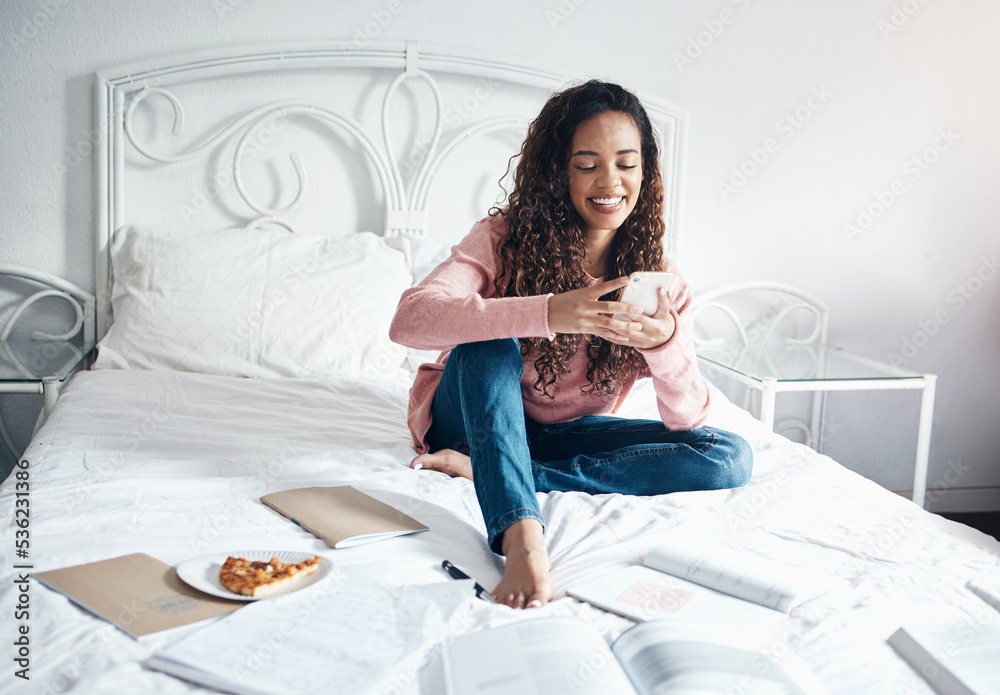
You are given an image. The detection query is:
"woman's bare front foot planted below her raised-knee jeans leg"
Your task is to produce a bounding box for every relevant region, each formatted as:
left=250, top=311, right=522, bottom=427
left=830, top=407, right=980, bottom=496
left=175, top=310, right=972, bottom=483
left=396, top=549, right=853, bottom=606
left=493, top=519, right=552, bottom=608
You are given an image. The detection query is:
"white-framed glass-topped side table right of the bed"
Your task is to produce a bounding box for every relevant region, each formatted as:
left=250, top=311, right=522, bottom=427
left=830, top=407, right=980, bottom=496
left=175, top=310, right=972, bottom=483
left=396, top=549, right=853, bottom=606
left=697, top=344, right=937, bottom=507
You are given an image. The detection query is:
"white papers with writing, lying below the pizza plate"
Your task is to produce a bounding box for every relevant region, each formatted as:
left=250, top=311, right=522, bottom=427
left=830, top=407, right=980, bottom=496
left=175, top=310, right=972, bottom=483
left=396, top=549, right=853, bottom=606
left=149, top=578, right=475, bottom=695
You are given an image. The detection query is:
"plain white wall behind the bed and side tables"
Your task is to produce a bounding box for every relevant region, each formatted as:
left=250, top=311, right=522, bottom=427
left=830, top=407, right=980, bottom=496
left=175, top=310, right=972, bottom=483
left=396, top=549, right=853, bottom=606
left=0, top=0, right=1000, bottom=510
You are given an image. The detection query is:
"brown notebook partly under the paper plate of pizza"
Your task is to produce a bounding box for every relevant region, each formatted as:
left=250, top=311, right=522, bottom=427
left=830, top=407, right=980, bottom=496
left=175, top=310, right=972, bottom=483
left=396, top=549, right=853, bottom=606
left=31, top=553, right=246, bottom=637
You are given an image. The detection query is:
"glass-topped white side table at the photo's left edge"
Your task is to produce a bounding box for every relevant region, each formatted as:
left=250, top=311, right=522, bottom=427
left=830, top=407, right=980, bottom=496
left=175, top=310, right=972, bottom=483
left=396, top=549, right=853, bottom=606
left=0, top=338, right=94, bottom=421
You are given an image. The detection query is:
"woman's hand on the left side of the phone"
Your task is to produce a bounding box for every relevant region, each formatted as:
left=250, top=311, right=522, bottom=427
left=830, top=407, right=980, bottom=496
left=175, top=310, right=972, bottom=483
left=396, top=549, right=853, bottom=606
left=549, top=276, right=642, bottom=345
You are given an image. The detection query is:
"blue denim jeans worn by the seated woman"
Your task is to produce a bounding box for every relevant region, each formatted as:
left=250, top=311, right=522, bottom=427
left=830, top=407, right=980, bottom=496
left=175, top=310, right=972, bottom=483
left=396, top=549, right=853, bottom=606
left=427, top=339, right=753, bottom=553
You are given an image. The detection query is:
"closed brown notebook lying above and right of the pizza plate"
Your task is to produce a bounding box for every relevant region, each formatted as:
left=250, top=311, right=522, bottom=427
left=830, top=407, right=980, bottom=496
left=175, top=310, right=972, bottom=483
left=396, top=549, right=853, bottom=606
left=260, top=485, right=427, bottom=548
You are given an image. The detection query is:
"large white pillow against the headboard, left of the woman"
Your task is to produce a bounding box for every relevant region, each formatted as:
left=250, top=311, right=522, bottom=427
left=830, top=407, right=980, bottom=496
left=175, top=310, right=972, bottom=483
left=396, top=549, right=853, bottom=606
left=94, top=226, right=412, bottom=378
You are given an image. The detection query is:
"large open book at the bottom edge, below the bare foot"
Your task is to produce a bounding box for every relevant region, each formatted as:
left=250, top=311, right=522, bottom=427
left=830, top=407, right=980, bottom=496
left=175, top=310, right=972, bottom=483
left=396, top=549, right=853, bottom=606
left=424, top=617, right=827, bottom=695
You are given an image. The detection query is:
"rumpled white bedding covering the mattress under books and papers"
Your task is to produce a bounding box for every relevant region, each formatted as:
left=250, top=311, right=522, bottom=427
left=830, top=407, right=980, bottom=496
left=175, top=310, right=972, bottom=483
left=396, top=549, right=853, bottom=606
left=0, top=370, right=1000, bottom=695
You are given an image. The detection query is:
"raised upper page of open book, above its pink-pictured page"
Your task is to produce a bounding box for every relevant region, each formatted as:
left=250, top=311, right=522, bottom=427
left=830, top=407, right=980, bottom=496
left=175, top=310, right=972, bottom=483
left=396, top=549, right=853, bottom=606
left=645, top=542, right=844, bottom=613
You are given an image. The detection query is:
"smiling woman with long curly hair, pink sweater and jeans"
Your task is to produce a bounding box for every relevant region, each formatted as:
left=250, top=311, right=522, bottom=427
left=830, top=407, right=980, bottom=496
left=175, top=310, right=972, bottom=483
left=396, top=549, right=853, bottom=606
left=390, top=80, right=752, bottom=608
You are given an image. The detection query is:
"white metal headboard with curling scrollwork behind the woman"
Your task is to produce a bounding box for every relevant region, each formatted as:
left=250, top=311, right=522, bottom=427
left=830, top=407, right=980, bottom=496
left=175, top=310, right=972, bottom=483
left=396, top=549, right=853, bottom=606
left=95, top=41, right=687, bottom=337
